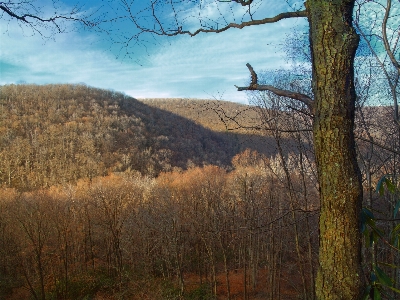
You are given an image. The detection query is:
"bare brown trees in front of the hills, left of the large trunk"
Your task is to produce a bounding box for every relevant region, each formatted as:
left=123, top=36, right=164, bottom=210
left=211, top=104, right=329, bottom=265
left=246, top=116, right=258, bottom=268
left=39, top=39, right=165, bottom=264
left=0, top=150, right=318, bottom=299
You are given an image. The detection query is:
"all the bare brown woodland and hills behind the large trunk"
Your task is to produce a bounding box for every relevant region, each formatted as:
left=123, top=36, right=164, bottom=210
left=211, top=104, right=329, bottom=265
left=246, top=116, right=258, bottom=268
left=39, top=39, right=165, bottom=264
left=0, top=85, right=400, bottom=300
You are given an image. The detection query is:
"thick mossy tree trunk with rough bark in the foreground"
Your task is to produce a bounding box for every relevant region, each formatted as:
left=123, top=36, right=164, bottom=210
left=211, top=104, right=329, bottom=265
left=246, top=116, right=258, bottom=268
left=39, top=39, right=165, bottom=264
left=306, top=0, right=363, bottom=300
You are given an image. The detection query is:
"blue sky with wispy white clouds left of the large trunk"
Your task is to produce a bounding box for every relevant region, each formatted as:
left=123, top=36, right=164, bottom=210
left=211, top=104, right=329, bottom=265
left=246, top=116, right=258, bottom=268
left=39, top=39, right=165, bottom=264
left=0, top=0, right=307, bottom=103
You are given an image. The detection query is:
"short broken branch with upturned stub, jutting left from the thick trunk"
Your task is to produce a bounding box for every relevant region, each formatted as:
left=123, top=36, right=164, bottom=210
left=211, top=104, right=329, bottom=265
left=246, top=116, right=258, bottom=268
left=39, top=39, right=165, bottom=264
left=235, top=63, right=314, bottom=111
